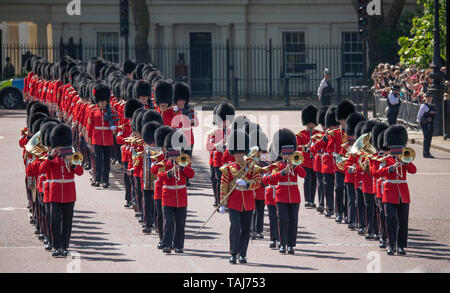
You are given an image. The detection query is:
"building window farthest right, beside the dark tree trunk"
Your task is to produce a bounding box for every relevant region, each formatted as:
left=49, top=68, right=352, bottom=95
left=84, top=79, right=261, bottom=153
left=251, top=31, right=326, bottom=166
left=342, top=32, right=363, bottom=77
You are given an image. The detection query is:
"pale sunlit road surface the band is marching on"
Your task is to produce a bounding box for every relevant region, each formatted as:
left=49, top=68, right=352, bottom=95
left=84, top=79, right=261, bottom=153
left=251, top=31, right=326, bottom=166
left=0, top=110, right=450, bottom=273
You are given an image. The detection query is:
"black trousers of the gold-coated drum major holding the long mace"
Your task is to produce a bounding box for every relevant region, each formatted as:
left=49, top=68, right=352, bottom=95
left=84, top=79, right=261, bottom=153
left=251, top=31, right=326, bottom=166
left=228, top=209, right=253, bottom=257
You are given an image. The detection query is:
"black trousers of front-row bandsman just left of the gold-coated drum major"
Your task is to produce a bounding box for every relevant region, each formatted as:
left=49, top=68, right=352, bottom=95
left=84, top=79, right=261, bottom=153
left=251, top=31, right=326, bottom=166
left=162, top=206, right=187, bottom=249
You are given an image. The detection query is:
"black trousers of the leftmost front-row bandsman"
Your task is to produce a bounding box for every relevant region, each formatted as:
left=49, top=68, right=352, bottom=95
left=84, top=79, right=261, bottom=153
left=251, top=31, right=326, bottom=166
left=51, top=202, right=75, bottom=249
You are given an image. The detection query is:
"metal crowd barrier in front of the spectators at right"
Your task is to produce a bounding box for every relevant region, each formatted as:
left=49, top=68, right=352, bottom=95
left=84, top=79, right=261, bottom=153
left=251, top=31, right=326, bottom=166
left=373, top=93, right=420, bottom=129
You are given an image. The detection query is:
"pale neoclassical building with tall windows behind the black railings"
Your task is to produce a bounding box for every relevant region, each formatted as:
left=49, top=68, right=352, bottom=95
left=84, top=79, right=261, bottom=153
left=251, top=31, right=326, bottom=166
left=0, top=0, right=416, bottom=95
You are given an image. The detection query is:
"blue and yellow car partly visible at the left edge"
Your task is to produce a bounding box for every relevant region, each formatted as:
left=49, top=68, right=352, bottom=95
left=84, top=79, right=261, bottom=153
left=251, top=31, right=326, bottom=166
left=0, top=78, right=24, bottom=109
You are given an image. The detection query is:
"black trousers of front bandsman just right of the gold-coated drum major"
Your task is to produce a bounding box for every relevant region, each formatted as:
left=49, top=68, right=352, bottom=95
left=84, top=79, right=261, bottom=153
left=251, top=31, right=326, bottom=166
left=277, top=202, right=300, bottom=247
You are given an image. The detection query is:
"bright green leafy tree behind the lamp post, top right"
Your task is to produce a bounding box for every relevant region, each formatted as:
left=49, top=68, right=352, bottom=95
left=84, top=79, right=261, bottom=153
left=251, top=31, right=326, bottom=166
left=398, top=0, right=447, bottom=68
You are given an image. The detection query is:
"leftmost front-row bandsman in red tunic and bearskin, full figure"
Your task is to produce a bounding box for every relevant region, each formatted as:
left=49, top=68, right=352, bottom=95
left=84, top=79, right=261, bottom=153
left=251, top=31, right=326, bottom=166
left=39, top=124, right=83, bottom=256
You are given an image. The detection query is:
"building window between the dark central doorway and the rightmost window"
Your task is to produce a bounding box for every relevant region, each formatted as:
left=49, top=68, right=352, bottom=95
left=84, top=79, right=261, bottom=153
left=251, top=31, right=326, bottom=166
left=283, top=32, right=306, bottom=76
